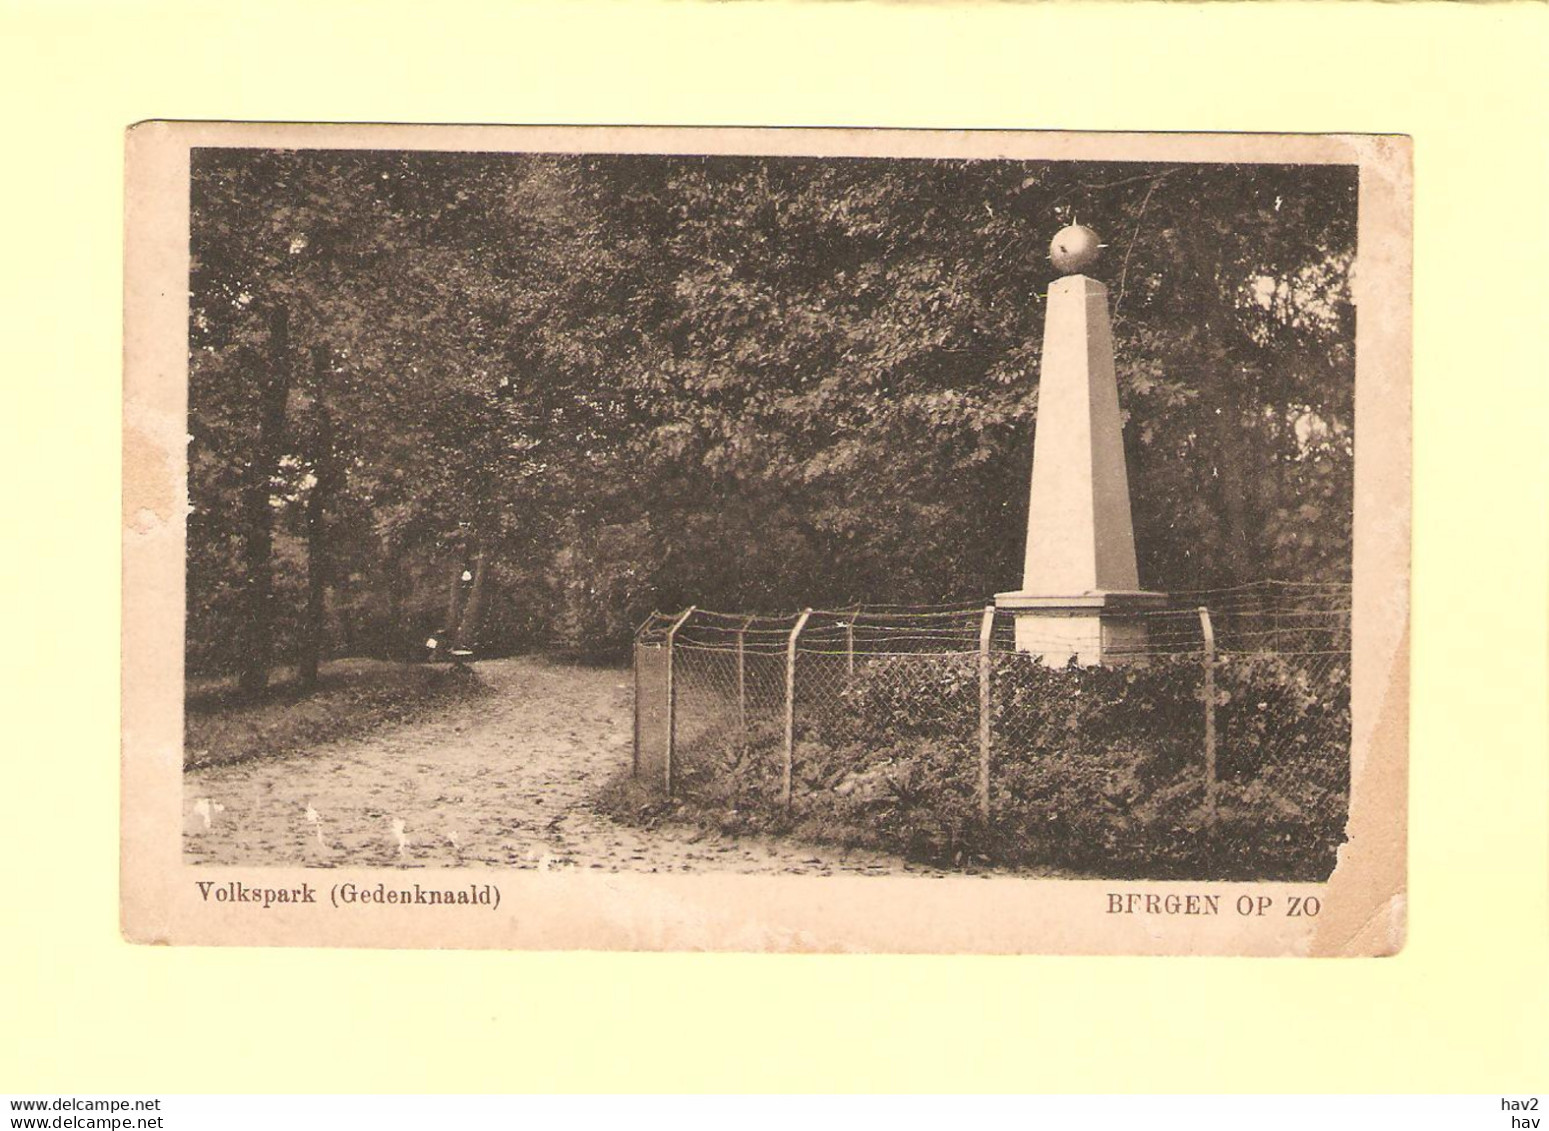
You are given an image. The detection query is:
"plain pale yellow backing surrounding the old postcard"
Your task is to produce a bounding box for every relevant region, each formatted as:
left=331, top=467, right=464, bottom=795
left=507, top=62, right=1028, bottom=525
left=0, top=0, right=1549, bottom=1092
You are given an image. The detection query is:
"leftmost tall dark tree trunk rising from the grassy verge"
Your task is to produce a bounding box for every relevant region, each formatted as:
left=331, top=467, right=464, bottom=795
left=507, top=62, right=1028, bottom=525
left=239, top=307, right=290, bottom=696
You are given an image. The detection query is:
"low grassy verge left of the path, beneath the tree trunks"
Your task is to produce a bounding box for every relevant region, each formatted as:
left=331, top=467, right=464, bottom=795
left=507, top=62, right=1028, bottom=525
left=183, top=658, right=491, bottom=768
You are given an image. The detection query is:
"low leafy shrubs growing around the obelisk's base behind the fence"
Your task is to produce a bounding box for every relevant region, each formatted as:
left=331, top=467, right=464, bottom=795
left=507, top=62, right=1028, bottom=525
left=653, top=654, right=1351, bottom=880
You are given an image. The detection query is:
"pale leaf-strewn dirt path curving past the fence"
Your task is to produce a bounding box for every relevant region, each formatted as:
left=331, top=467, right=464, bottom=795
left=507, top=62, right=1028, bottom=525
left=183, top=658, right=934, bottom=874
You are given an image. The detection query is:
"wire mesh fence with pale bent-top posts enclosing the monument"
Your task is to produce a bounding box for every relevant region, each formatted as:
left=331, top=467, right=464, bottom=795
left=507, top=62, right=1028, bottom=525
left=635, top=583, right=1351, bottom=877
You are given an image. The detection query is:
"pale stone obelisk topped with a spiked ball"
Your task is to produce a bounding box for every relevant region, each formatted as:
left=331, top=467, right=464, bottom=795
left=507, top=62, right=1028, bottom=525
left=994, top=226, right=1166, bottom=666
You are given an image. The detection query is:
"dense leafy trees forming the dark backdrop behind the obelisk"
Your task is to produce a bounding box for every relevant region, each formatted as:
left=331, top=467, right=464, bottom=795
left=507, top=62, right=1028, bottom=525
left=187, top=149, right=1355, bottom=691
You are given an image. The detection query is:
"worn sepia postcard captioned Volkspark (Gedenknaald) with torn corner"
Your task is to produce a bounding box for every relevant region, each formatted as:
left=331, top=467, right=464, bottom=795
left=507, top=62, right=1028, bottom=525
left=125, top=124, right=1408, bottom=953
